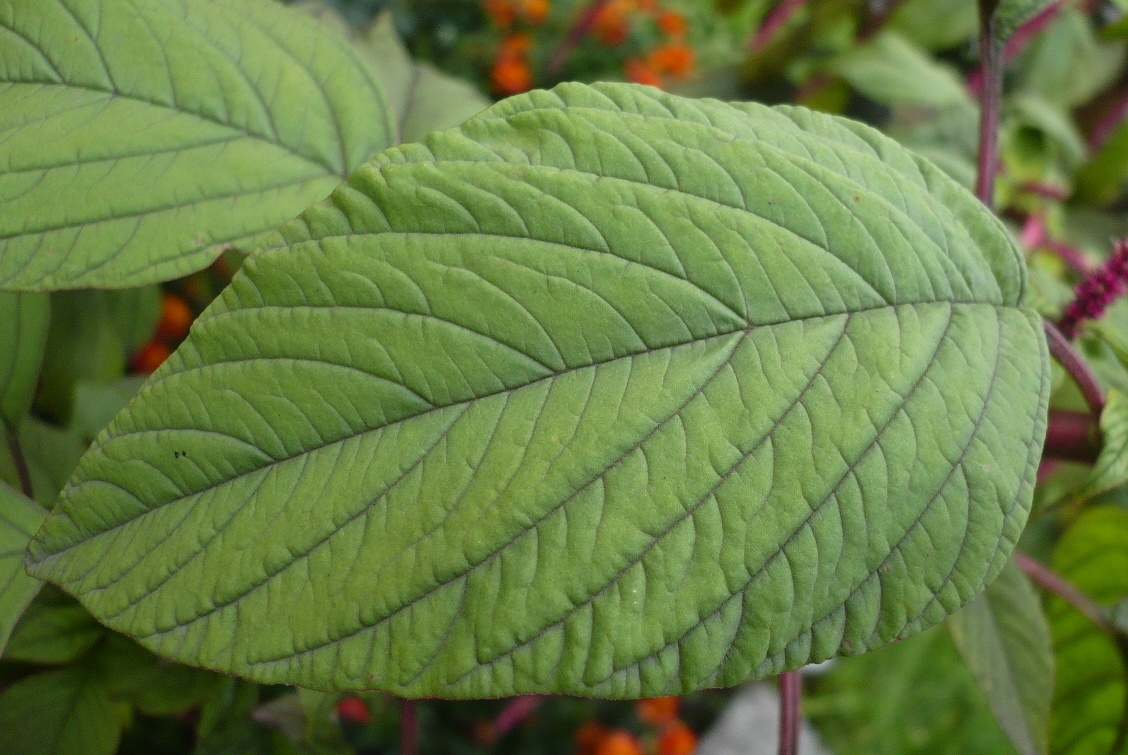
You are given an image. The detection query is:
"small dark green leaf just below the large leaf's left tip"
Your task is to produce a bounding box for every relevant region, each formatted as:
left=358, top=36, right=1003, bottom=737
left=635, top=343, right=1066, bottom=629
left=0, top=585, right=106, bottom=659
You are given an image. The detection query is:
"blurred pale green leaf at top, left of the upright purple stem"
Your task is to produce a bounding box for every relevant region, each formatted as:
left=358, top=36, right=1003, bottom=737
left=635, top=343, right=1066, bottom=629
left=830, top=30, right=970, bottom=107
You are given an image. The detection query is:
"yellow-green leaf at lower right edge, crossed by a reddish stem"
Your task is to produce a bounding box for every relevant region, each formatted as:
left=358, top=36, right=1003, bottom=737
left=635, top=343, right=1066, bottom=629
left=1046, top=507, right=1128, bottom=755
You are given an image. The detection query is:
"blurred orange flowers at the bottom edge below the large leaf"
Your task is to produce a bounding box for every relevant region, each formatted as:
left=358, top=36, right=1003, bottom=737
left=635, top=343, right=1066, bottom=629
left=575, top=697, right=697, bottom=755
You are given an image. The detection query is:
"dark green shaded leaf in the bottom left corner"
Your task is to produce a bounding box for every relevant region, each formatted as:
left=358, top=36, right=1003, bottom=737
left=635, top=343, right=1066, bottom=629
left=0, top=667, right=122, bottom=755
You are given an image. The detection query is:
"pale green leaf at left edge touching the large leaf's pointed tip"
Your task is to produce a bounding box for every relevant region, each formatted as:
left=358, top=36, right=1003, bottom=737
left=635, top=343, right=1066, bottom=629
left=0, top=482, right=47, bottom=656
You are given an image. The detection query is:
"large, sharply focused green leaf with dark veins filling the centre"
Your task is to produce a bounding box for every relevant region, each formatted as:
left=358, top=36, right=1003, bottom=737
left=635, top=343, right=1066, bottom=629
left=30, top=85, right=1049, bottom=697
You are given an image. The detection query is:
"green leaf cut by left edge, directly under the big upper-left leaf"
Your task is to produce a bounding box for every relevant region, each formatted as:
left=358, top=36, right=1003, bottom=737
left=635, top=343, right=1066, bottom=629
left=0, top=293, right=51, bottom=434
